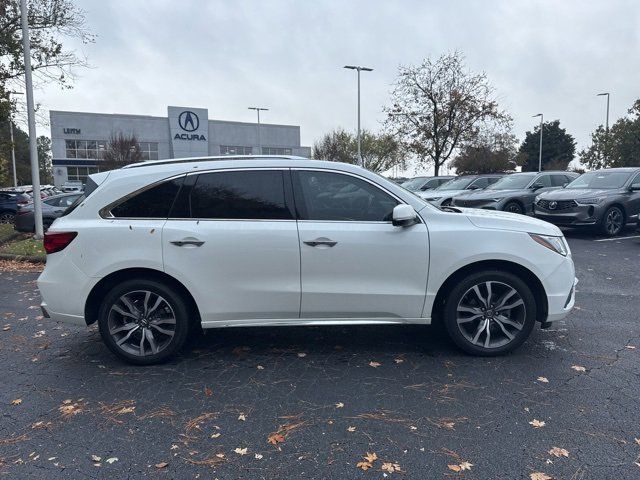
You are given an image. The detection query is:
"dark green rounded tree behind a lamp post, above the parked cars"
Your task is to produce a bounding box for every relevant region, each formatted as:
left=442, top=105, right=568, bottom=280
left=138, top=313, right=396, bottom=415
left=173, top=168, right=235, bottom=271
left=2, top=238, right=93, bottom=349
left=519, top=120, right=576, bottom=172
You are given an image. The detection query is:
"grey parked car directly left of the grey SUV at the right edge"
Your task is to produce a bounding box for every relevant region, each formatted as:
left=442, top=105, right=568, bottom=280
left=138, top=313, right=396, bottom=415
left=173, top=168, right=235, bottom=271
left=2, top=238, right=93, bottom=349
left=451, top=171, right=578, bottom=215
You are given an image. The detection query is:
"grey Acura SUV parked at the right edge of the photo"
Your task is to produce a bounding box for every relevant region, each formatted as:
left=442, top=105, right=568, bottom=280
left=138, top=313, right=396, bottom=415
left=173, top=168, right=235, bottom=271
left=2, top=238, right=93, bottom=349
left=535, top=168, right=640, bottom=236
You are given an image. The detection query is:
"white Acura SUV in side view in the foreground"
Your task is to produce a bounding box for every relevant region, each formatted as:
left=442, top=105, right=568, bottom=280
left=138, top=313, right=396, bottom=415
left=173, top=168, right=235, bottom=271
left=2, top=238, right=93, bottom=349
left=38, top=157, right=575, bottom=364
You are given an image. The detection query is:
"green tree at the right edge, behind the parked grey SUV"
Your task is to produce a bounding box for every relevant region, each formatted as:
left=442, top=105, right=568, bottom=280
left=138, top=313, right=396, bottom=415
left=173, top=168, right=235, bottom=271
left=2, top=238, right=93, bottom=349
left=580, top=99, right=640, bottom=169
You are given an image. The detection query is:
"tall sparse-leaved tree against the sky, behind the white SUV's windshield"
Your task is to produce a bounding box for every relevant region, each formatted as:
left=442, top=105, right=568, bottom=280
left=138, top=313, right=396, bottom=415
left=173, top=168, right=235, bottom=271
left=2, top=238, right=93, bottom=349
left=385, top=52, right=511, bottom=175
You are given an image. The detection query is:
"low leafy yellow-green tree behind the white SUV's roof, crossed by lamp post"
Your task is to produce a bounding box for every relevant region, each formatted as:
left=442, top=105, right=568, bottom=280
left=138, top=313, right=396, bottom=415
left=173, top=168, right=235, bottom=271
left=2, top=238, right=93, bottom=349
left=313, top=129, right=406, bottom=173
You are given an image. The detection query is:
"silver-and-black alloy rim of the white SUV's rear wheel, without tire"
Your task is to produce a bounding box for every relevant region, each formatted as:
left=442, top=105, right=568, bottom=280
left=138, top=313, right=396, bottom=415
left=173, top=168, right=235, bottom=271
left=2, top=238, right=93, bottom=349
left=107, top=290, right=176, bottom=357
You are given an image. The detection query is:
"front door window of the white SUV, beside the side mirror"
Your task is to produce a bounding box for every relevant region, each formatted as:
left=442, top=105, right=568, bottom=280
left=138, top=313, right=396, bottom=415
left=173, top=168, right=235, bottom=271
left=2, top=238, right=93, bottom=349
left=294, top=170, right=399, bottom=222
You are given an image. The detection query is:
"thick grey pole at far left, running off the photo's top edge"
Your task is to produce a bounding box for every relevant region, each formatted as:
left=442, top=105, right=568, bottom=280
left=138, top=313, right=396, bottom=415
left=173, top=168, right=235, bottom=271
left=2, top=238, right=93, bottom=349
left=20, top=0, right=43, bottom=239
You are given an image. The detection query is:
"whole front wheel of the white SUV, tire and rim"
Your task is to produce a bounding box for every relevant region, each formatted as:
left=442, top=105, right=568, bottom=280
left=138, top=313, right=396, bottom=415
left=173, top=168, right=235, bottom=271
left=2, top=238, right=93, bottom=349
left=444, top=271, right=536, bottom=356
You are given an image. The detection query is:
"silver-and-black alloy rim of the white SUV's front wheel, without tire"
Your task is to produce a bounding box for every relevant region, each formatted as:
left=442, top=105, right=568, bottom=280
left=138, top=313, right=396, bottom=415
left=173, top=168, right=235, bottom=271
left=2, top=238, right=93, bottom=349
left=456, top=281, right=526, bottom=349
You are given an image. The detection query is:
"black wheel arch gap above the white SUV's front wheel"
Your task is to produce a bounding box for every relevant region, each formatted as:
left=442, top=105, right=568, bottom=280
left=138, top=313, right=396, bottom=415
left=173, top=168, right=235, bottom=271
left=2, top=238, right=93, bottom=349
left=431, top=260, right=549, bottom=323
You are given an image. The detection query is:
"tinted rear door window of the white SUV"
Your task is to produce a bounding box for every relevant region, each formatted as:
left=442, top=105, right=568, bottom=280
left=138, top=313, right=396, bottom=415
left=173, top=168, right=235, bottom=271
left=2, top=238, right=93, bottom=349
left=190, top=170, right=293, bottom=220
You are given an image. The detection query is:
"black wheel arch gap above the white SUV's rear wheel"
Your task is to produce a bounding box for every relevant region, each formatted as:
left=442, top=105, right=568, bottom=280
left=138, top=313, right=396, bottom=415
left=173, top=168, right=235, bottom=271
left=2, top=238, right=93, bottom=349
left=84, top=268, right=201, bottom=325
